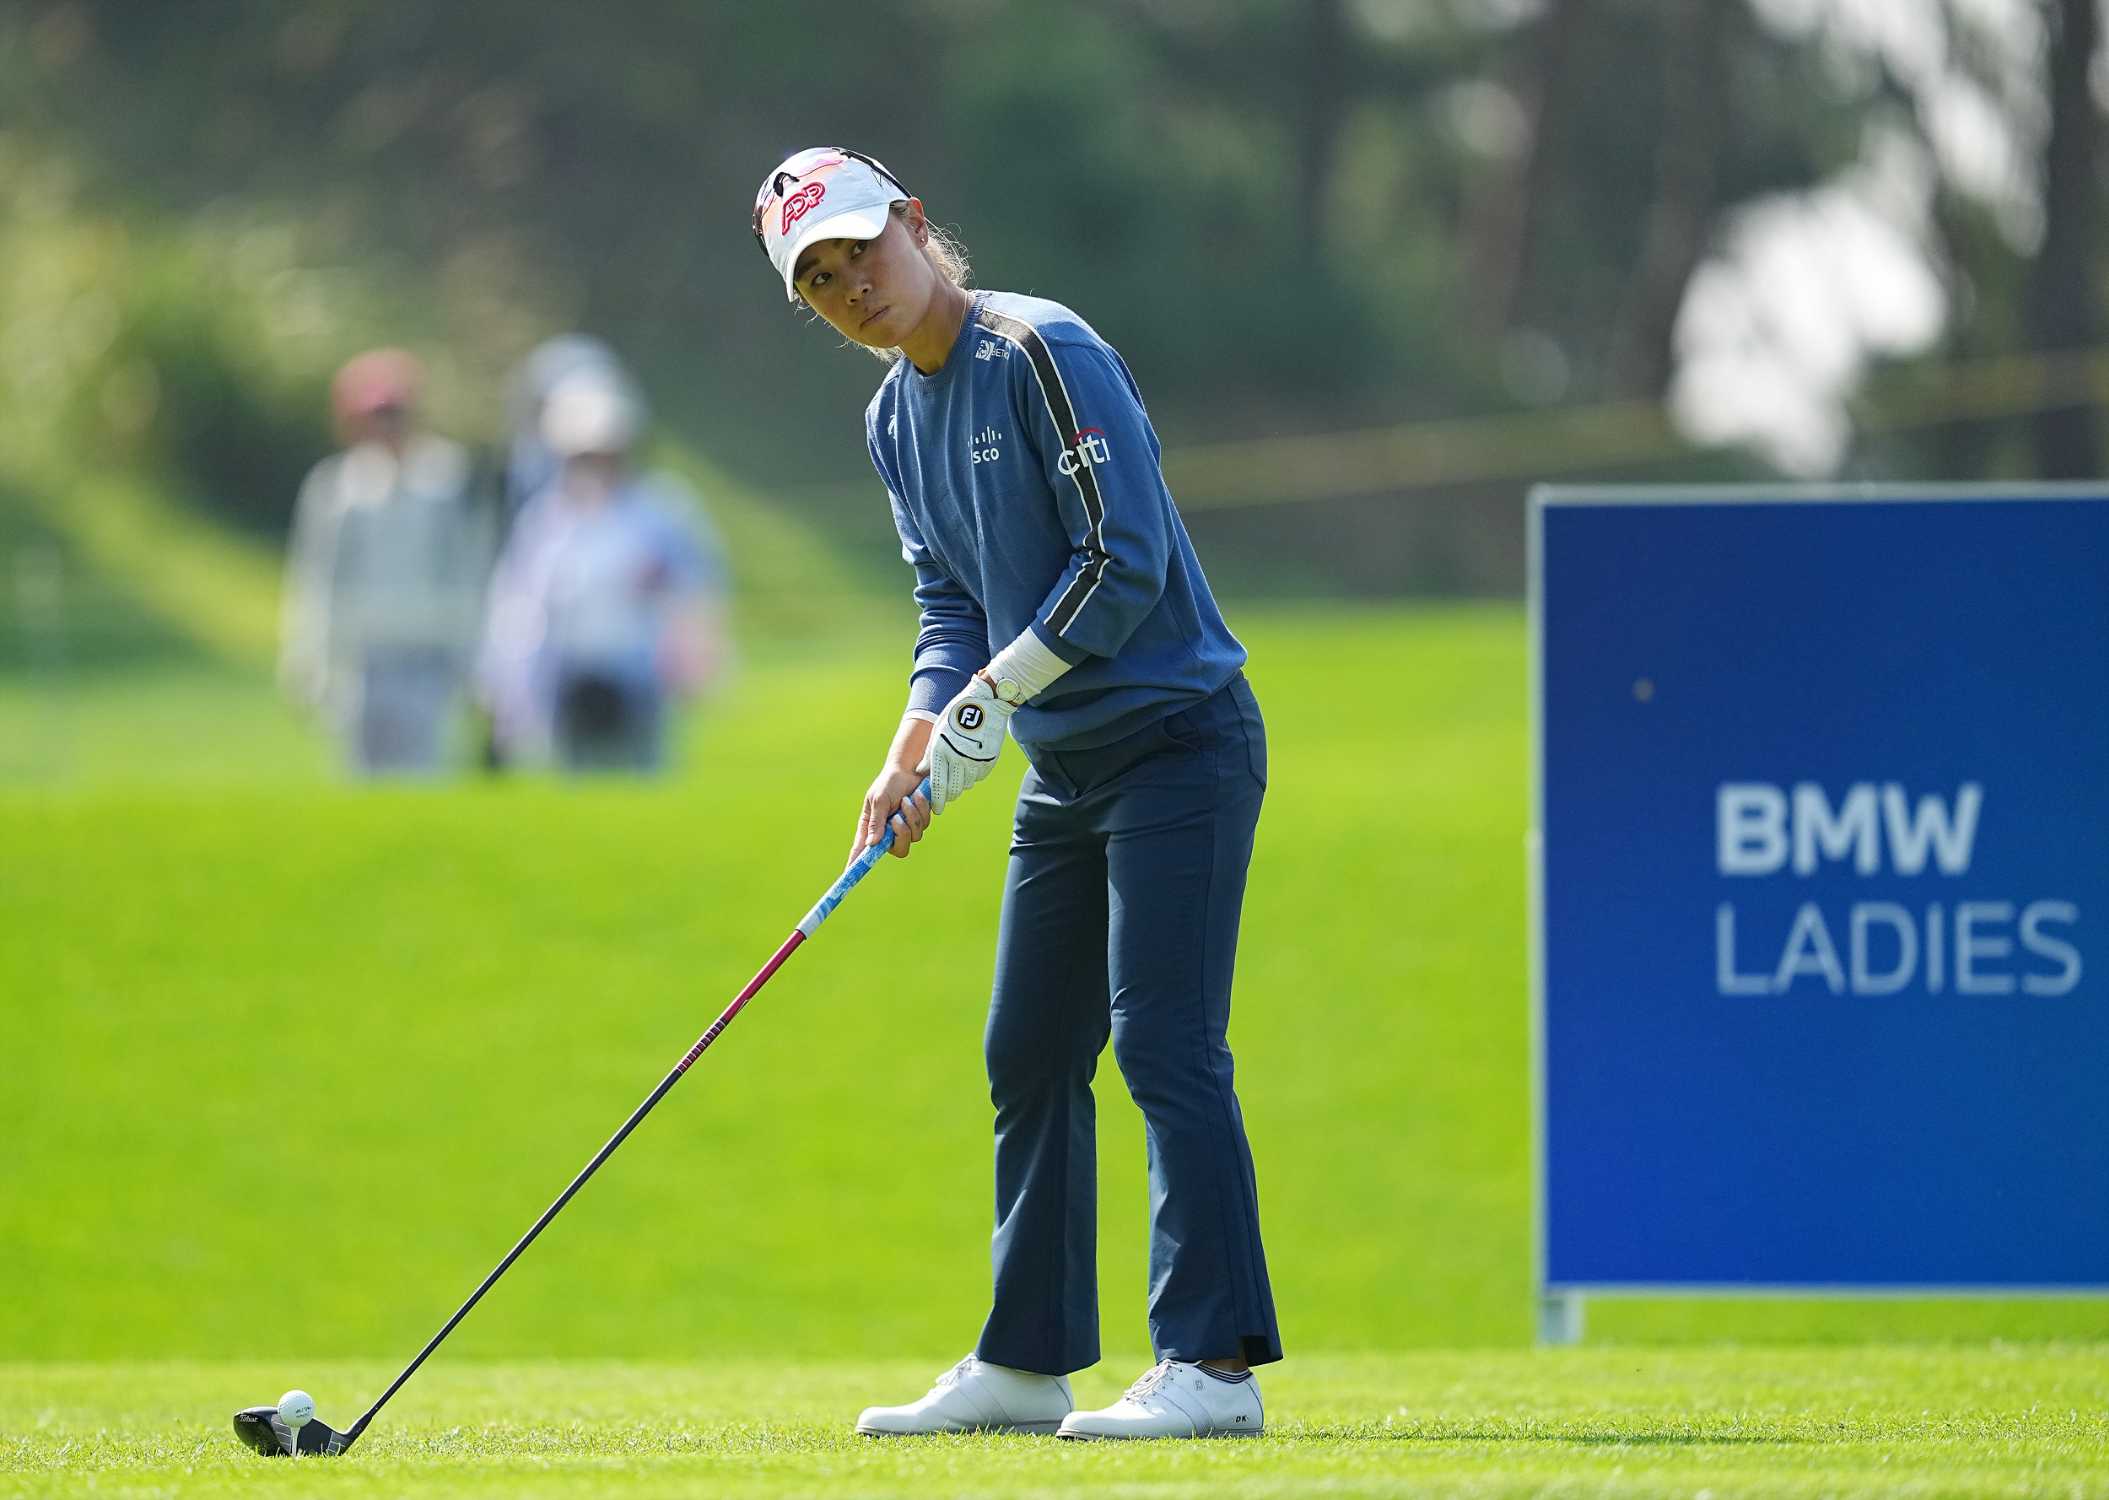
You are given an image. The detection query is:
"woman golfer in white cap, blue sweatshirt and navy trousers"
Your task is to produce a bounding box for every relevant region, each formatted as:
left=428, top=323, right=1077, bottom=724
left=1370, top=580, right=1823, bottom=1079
left=755, top=148, right=1282, bottom=1439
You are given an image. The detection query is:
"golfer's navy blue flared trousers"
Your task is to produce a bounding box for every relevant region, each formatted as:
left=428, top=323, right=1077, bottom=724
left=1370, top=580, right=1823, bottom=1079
left=974, top=675, right=1282, bottom=1376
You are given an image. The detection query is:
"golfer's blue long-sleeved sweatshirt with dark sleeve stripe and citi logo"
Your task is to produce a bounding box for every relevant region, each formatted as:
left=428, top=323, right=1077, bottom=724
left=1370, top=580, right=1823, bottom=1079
left=865, top=291, right=1244, bottom=751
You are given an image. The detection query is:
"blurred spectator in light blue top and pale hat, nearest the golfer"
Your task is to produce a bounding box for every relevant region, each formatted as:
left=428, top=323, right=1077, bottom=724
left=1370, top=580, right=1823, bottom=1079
left=481, top=365, right=725, bottom=772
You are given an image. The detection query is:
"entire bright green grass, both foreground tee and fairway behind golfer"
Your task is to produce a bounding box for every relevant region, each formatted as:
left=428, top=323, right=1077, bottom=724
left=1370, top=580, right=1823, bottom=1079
left=0, top=608, right=2109, bottom=1494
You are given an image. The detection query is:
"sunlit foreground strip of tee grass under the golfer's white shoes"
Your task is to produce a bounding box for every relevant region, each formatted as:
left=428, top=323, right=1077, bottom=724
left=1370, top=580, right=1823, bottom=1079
left=0, top=1344, right=2109, bottom=1500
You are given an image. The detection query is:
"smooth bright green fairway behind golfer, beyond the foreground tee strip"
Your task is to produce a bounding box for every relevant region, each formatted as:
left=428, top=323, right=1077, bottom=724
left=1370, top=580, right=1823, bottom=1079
left=0, top=608, right=2109, bottom=1361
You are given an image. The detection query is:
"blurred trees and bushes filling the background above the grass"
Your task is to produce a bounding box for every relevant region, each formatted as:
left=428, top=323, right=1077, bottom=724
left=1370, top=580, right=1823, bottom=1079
left=0, top=0, right=2103, bottom=633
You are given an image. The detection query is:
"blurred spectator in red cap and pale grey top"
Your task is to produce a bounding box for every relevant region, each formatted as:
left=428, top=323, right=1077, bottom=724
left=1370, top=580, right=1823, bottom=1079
left=280, top=348, right=491, bottom=776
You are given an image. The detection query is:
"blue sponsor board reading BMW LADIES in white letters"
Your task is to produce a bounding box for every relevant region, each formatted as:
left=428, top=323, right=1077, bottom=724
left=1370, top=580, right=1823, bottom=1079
left=1531, top=487, right=2109, bottom=1293
